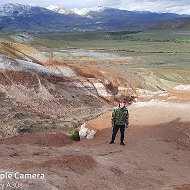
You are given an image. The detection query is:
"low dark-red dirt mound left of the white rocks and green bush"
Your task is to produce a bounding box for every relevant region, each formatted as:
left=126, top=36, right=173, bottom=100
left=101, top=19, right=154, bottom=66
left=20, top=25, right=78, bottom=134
left=0, top=133, right=74, bottom=147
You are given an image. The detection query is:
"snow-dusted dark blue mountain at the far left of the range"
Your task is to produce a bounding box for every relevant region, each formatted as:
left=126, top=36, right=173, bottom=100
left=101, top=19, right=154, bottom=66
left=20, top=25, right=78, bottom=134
left=0, top=3, right=89, bottom=33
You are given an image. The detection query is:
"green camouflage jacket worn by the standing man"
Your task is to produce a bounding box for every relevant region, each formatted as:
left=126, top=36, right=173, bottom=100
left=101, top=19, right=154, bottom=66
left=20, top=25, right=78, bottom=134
left=112, top=107, right=129, bottom=125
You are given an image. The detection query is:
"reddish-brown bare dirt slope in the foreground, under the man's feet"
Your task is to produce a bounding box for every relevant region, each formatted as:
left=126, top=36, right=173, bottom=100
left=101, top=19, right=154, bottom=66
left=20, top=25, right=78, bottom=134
left=0, top=99, right=190, bottom=190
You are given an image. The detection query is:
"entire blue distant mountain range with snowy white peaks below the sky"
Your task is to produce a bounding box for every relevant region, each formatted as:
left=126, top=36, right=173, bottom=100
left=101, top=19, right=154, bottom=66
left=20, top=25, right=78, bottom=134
left=0, top=3, right=187, bottom=33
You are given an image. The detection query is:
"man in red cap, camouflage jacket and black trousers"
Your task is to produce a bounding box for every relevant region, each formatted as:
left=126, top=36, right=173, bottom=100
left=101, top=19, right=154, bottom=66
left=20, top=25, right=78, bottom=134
left=110, top=100, right=129, bottom=146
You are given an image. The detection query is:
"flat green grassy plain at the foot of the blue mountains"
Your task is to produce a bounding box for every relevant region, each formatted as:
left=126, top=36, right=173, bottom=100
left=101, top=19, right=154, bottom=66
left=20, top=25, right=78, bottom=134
left=0, top=30, right=190, bottom=54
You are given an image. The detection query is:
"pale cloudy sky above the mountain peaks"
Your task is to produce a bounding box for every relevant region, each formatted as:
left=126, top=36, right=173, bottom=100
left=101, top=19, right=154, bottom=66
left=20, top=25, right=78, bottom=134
left=0, top=0, right=190, bottom=15
